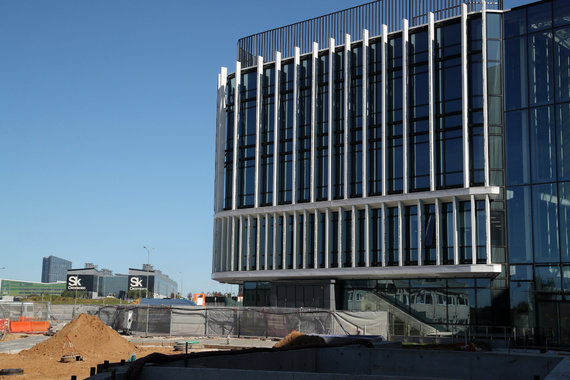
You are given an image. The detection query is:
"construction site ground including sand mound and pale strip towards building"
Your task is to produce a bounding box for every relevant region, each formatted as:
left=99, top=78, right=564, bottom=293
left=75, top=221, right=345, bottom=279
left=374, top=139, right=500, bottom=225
left=0, top=314, right=276, bottom=380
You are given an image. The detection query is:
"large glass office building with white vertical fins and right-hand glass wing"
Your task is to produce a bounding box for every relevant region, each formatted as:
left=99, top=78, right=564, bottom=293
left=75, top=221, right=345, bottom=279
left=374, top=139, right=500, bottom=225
left=212, top=0, right=570, bottom=344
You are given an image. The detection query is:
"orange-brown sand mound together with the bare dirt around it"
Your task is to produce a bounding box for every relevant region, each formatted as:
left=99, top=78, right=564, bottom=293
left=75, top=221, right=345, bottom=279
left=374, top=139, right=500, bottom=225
left=0, top=314, right=175, bottom=380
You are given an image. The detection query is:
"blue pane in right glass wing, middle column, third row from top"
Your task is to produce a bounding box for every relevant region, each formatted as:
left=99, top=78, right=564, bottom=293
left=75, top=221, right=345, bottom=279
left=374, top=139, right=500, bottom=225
left=530, top=107, right=556, bottom=182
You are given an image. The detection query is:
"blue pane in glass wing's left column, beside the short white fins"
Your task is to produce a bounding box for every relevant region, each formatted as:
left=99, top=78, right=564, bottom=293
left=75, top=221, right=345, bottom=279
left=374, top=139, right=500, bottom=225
left=507, top=186, right=533, bottom=263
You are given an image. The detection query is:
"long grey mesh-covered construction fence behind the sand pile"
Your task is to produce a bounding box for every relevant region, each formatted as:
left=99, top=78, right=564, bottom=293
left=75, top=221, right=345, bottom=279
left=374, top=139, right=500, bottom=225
left=0, top=302, right=388, bottom=337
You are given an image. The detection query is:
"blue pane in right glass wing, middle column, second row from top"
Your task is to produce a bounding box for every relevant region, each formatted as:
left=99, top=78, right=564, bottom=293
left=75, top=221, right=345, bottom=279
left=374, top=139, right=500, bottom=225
left=528, top=32, right=554, bottom=105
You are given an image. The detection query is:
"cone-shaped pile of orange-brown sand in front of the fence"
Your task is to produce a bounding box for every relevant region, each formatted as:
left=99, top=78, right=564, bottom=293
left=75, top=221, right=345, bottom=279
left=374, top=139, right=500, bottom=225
left=22, top=314, right=136, bottom=358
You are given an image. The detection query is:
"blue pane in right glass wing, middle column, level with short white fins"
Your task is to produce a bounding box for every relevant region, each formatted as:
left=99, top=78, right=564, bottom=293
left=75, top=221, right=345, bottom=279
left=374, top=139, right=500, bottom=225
left=532, top=183, right=560, bottom=263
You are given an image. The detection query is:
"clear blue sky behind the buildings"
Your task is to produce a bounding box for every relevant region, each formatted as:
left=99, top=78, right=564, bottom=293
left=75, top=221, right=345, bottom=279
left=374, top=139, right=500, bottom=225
left=0, top=0, right=527, bottom=292
